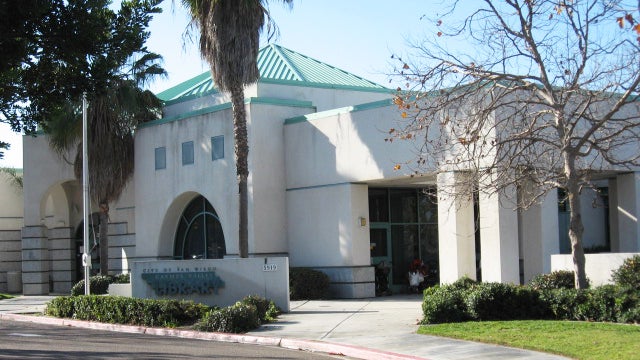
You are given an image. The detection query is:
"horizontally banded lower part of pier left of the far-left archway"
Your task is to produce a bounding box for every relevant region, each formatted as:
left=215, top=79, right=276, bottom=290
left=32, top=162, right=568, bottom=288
left=22, top=226, right=49, bottom=295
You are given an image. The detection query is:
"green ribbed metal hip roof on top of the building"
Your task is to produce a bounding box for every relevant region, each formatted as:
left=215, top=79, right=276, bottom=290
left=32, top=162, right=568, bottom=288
left=157, top=44, right=389, bottom=103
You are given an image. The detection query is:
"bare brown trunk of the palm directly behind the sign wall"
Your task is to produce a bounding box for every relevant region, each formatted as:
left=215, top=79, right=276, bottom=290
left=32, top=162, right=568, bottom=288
left=231, top=86, right=249, bottom=258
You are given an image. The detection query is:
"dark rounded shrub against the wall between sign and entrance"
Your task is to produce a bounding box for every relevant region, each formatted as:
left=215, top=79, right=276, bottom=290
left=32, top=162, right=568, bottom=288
left=289, top=268, right=329, bottom=300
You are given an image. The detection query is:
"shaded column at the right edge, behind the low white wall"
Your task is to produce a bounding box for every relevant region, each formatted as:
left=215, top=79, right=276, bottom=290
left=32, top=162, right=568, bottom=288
left=612, top=172, right=640, bottom=252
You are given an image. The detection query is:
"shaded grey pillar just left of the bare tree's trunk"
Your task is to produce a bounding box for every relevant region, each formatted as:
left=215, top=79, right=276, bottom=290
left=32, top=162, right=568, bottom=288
left=518, top=190, right=560, bottom=284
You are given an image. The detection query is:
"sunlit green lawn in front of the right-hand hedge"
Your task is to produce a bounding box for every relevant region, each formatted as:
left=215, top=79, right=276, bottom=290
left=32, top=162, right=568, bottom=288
left=418, top=320, right=640, bottom=360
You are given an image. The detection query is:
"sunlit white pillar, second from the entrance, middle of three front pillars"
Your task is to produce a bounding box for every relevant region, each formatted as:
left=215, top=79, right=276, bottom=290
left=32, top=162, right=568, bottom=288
left=478, top=185, right=520, bottom=284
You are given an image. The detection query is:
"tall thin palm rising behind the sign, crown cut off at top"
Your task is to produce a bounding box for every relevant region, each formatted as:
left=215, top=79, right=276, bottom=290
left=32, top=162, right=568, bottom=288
left=182, top=0, right=293, bottom=258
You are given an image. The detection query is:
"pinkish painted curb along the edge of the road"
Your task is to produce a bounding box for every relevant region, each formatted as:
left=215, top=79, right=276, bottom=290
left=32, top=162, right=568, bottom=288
left=0, top=313, right=427, bottom=360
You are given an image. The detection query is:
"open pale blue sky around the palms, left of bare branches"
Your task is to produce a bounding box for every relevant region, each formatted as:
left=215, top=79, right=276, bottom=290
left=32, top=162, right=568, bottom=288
left=0, top=0, right=434, bottom=168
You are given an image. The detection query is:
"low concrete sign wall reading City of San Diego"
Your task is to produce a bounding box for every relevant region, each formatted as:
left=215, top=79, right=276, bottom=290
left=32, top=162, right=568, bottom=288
left=131, top=257, right=289, bottom=312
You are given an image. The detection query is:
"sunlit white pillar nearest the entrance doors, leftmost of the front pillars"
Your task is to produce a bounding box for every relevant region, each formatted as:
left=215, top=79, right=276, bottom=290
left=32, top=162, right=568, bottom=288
left=437, top=172, right=476, bottom=284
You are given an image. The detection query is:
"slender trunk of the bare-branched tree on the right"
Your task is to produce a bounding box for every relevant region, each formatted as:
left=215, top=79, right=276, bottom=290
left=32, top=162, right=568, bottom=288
left=565, top=155, right=588, bottom=289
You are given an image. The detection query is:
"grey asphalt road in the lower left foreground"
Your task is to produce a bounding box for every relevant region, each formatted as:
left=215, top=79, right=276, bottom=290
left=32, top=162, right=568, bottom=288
left=0, top=320, right=344, bottom=360
